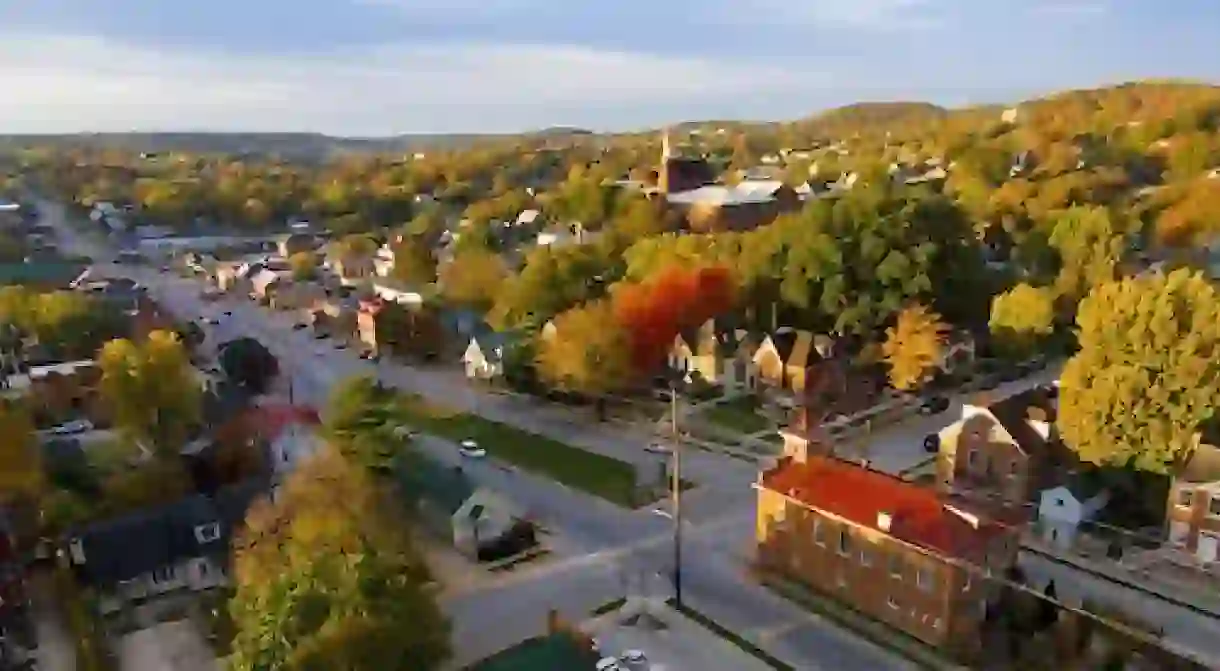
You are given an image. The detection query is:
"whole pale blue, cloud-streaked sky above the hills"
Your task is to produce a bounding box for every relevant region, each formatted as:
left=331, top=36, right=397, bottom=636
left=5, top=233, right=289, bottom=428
left=0, top=0, right=1220, bottom=137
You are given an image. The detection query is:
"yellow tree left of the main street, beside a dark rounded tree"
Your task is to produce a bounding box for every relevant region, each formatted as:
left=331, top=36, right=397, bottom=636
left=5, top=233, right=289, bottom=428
left=98, top=331, right=201, bottom=454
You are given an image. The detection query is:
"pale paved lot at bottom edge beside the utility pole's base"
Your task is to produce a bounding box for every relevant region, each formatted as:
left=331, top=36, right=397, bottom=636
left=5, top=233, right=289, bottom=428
left=581, top=601, right=771, bottom=671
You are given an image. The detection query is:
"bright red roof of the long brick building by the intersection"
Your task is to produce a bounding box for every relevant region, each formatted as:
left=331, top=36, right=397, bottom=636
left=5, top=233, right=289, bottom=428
left=761, top=455, right=1003, bottom=560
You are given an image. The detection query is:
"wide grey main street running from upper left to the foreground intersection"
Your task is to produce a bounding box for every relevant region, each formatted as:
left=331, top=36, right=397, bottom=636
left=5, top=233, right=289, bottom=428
left=43, top=204, right=913, bottom=671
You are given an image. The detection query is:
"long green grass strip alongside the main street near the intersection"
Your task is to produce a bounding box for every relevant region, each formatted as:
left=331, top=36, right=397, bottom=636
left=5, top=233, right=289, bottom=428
left=395, top=398, right=642, bottom=508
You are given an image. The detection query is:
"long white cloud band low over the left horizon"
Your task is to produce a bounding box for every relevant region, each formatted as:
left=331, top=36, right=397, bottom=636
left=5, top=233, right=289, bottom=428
left=0, top=34, right=819, bottom=134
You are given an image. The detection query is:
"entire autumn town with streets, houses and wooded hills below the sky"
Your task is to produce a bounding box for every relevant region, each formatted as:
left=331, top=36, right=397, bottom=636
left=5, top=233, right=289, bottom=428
left=0, top=83, right=1220, bottom=671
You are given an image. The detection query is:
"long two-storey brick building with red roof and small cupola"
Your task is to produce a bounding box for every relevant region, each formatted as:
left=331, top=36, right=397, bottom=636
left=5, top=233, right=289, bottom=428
left=756, top=417, right=1020, bottom=658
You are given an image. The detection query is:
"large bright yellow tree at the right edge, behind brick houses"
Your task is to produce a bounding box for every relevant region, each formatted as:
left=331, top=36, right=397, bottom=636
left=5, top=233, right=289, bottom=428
left=1058, top=270, right=1220, bottom=472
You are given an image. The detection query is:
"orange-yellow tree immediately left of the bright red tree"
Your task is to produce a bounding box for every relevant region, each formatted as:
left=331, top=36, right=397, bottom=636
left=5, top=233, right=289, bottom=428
left=537, top=299, right=632, bottom=414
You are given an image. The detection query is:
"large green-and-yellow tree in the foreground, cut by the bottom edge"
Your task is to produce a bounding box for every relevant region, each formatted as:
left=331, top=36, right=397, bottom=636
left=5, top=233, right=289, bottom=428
left=228, top=448, right=450, bottom=671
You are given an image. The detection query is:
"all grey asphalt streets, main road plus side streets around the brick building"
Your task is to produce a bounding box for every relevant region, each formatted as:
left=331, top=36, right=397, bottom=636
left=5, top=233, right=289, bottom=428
left=43, top=204, right=1220, bottom=671
